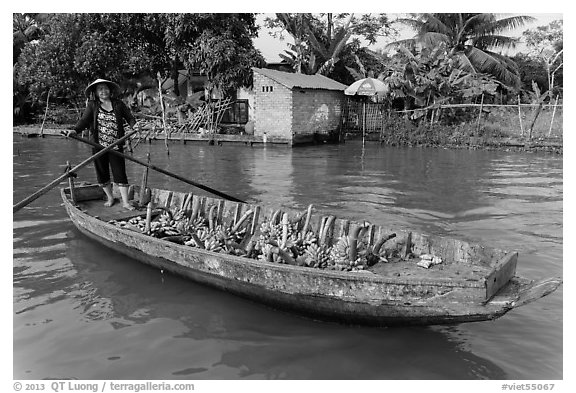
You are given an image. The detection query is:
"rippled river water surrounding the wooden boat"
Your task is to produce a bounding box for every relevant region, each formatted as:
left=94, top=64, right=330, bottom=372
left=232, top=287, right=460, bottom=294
left=13, top=135, right=563, bottom=380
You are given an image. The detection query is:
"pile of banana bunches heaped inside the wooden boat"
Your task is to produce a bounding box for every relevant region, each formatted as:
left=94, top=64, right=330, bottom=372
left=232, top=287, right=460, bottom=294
left=109, top=204, right=395, bottom=272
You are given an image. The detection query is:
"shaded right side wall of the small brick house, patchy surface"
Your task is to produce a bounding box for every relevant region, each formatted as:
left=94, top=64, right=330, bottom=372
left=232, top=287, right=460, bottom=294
left=292, top=88, right=344, bottom=137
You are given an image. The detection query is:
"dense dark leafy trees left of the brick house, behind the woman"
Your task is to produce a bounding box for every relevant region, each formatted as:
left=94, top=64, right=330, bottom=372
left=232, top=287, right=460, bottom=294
left=13, top=13, right=263, bottom=119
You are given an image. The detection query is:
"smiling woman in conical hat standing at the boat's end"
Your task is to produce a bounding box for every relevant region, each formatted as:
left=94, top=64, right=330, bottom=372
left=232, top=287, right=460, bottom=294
left=69, top=79, right=136, bottom=210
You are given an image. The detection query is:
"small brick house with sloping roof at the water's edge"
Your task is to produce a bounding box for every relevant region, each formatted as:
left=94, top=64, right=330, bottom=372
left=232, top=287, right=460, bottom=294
left=253, top=68, right=346, bottom=145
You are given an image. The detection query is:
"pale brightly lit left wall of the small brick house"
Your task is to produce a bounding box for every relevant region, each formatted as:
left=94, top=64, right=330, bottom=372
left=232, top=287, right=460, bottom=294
left=254, top=72, right=292, bottom=143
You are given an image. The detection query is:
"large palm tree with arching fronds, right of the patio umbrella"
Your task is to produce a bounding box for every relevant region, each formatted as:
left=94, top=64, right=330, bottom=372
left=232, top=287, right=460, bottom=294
left=389, top=13, right=535, bottom=88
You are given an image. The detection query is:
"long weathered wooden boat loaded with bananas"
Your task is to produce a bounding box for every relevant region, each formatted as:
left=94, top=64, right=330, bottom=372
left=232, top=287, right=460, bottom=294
left=61, top=184, right=561, bottom=326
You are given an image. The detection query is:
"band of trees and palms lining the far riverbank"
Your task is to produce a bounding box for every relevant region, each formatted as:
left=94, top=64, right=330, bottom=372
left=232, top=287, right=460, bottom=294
left=13, top=13, right=563, bottom=124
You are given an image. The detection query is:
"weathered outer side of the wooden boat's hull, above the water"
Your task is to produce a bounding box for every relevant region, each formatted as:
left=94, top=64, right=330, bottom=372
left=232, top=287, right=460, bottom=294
left=62, top=185, right=559, bottom=326
